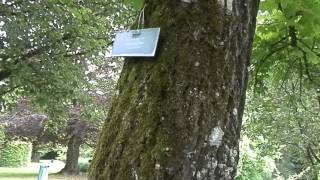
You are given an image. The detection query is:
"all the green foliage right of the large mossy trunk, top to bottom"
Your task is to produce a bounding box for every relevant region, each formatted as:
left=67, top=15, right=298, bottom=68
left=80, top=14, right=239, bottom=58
left=242, top=0, right=320, bottom=179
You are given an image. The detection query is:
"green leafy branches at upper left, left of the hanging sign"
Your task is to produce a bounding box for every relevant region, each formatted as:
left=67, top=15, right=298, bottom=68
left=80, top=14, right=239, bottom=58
left=1, top=0, right=99, bottom=102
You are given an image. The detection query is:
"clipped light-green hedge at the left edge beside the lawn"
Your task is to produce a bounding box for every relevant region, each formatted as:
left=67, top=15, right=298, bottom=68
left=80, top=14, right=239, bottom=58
left=0, top=142, right=31, bottom=167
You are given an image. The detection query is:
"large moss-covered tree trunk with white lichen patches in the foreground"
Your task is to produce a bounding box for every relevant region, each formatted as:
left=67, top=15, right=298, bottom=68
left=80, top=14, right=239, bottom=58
left=89, top=0, right=258, bottom=180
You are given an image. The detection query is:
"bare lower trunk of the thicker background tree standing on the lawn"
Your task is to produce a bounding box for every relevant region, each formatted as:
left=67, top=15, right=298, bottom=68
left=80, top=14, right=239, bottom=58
left=60, top=135, right=82, bottom=175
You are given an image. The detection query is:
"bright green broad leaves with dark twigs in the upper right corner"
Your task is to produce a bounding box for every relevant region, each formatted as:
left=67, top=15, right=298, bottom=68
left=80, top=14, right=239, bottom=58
left=251, top=0, right=320, bottom=92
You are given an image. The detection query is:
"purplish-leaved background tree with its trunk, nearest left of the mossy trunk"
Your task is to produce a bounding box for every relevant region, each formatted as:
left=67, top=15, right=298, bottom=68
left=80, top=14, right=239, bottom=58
left=61, top=89, right=110, bottom=175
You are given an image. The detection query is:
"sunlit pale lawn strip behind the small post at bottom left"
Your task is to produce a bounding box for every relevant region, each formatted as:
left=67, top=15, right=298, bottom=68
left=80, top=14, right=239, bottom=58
left=0, top=161, right=87, bottom=180
